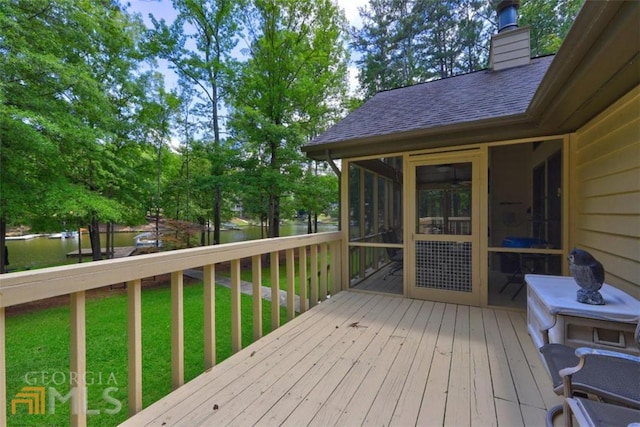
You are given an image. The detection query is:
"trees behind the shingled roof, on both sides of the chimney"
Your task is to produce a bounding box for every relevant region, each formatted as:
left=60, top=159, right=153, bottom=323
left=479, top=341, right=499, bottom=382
left=351, top=0, right=584, bottom=99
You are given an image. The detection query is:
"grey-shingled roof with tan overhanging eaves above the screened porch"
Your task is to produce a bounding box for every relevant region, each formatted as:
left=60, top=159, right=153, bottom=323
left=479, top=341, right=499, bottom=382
left=303, top=1, right=640, bottom=159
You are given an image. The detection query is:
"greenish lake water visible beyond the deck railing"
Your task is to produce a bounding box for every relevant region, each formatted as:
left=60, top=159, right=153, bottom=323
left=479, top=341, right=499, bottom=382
left=7, top=223, right=337, bottom=270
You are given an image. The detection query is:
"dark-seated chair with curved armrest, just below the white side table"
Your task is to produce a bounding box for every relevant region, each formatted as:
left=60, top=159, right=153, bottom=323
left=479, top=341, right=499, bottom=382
left=540, top=344, right=640, bottom=426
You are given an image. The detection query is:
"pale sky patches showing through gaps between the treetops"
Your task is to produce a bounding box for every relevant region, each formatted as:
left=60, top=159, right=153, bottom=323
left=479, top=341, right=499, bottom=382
left=128, top=0, right=368, bottom=90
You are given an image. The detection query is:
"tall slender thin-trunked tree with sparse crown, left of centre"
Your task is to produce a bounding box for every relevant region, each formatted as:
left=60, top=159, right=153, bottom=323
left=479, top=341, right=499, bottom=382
left=151, top=0, right=243, bottom=243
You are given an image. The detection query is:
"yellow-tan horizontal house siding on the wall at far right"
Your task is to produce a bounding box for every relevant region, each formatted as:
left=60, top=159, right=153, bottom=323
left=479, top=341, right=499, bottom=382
left=571, top=86, right=640, bottom=299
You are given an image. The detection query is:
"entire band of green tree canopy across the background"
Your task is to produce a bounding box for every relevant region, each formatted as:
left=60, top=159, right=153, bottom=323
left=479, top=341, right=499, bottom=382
left=0, top=0, right=583, bottom=272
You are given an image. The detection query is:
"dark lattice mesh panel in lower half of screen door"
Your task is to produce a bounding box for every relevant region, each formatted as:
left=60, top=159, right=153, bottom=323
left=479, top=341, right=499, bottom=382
left=416, top=241, right=472, bottom=292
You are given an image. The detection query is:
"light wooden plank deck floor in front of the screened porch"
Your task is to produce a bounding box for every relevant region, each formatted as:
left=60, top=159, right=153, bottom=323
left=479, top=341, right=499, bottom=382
left=124, top=291, right=560, bottom=426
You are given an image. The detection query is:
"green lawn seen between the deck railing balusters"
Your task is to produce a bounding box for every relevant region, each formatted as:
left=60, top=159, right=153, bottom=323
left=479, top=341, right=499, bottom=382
left=6, top=283, right=286, bottom=426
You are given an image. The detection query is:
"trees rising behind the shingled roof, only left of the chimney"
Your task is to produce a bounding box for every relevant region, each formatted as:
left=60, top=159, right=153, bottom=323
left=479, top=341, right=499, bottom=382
left=351, top=0, right=489, bottom=98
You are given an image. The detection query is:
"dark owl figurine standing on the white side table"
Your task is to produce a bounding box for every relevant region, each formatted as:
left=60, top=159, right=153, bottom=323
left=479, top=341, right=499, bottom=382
left=568, top=248, right=604, bottom=305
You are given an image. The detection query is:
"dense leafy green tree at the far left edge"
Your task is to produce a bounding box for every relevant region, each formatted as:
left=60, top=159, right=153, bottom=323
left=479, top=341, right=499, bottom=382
left=0, top=0, right=153, bottom=268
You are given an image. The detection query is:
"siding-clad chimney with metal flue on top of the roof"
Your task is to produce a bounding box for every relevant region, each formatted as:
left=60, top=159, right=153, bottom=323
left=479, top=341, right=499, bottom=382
left=489, top=0, right=531, bottom=71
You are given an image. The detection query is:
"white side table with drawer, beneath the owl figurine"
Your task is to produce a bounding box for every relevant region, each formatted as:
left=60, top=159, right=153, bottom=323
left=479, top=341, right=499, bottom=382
left=525, top=274, right=640, bottom=355
